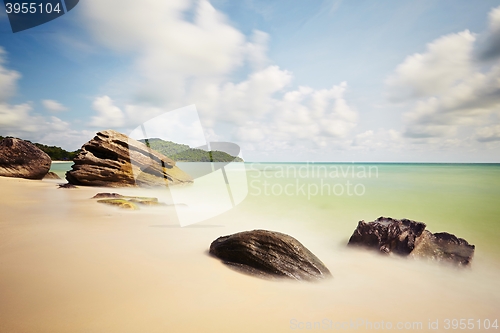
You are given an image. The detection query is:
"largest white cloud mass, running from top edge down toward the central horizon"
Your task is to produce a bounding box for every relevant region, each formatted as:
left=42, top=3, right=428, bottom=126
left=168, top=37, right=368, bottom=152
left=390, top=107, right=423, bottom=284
left=83, top=0, right=357, bottom=153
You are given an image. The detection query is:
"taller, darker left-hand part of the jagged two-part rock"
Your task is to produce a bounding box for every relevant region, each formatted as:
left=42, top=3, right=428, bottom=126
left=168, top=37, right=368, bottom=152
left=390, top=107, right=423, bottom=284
left=349, top=217, right=425, bottom=255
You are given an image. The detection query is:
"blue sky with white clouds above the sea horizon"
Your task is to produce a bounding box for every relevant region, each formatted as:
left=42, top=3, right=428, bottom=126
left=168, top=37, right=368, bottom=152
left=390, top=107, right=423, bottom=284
left=0, top=0, right=500, bottom=163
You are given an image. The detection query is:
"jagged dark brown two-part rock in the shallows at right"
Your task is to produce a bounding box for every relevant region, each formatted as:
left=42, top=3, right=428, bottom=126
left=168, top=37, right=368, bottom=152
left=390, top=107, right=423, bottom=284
left=348, top=217, right=475, bottom=266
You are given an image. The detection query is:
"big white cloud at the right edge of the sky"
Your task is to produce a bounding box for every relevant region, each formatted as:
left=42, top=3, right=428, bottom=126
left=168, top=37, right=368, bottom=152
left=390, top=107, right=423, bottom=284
left=386, top=8, right=500, bottom=146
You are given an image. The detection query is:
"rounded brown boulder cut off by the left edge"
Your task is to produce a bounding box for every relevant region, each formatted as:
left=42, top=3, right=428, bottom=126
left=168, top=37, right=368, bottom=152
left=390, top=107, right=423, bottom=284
left=0, top=138, right=52, bottom=179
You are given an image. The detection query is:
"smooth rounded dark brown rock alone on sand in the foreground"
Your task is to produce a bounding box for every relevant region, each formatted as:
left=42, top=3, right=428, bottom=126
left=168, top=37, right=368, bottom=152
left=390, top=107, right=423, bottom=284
left=210, top=230, right=331, bottom=280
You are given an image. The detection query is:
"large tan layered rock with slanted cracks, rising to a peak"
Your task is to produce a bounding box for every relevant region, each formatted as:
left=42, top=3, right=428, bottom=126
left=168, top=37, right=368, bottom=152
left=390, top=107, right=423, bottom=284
left=66, top=130, right=193, bottom=187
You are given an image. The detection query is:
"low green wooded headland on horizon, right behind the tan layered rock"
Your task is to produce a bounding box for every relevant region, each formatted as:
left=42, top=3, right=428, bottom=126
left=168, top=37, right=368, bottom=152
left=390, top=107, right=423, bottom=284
left=139, top=138, right=243, bottom=162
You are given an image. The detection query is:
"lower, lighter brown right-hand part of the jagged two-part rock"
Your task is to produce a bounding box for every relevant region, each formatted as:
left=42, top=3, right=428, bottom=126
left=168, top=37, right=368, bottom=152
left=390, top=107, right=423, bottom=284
left=411, top=230, right=475, bottom=266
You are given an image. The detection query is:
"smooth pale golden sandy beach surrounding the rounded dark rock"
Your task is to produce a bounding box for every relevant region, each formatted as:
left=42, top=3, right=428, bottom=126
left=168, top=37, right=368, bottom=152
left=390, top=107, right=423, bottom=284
left=0, top=177, right=500, bottom=333
